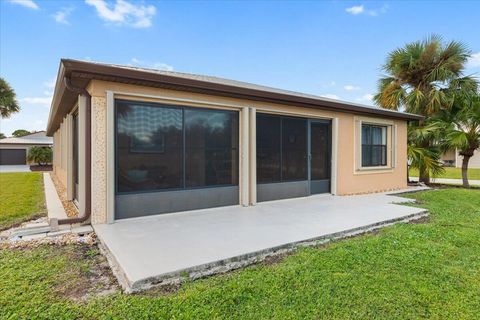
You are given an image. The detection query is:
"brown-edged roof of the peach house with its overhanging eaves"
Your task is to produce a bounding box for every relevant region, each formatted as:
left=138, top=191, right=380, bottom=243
left=47, top=59, right=423, bottom=135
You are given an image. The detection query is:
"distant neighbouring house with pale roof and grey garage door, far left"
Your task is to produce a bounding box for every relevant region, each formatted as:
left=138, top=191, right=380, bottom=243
left=0, top=131, right=53, bottom=165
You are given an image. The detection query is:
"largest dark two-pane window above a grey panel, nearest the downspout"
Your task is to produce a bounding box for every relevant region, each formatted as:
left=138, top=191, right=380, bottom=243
left=115, top=100, right=238, bottom=193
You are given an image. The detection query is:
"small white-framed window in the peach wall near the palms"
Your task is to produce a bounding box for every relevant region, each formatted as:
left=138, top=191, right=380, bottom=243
left=362, top=124, right=387, bottom=167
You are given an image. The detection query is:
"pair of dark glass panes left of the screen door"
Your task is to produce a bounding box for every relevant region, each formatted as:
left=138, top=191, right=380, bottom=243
left=257, top=114, right=307, bottom=183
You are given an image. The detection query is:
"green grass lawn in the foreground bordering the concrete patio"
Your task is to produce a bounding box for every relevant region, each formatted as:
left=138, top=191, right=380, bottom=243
left=0, top=188, right=480, bottom=319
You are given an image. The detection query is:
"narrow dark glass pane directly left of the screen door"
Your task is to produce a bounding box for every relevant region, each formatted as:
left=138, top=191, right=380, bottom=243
left=282, top=118, right=307, bottom=181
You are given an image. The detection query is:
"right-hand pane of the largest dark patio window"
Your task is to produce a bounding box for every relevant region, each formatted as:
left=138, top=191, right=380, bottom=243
left=185, top=109, right=238, bottom=187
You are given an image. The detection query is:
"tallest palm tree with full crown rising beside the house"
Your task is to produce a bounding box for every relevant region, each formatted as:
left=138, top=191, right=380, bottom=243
left=374, top=35, right=478, bottom=183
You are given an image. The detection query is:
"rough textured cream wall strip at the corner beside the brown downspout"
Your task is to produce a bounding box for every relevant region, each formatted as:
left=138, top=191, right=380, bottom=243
left=92, top=97, right=107, bottom=224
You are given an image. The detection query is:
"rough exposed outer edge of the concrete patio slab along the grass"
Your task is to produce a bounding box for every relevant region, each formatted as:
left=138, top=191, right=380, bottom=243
left=98, top=210, right=429, bottom=293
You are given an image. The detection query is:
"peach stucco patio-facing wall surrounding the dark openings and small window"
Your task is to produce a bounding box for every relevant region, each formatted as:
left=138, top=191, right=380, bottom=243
left=83, top=80, right=407, bottom=223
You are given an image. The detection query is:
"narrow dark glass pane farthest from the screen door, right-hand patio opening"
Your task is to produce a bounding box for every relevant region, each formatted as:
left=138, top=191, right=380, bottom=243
left=257, top=114, right=281, bottom=183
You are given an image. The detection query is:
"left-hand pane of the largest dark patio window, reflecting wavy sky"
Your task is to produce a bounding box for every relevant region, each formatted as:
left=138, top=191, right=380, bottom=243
left=116, top=101, right=183, bottom=192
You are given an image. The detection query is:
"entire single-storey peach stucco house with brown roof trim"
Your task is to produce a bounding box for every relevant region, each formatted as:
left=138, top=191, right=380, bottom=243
left=47, top=59, right=421, bottom=224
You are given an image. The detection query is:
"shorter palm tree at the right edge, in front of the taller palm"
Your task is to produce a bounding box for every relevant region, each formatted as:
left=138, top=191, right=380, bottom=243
left=434, top=95, right=480, bottom=188
